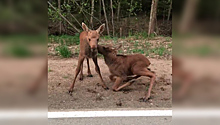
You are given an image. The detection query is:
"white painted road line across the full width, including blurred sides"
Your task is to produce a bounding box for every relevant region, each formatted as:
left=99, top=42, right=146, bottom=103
left=0, top=109, right=220, bottom=119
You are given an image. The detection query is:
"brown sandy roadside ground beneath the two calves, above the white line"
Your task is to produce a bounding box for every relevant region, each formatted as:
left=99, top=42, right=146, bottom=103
left=48, top=57, right=172, bottom=111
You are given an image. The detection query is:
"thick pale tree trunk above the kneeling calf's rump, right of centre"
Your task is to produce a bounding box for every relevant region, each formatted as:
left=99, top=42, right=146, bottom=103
left=148, top=0, right=158, bottom=35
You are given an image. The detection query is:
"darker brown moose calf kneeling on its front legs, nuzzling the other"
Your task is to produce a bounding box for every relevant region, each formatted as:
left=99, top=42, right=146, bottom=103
left=98, top=45, right=156, bottom=102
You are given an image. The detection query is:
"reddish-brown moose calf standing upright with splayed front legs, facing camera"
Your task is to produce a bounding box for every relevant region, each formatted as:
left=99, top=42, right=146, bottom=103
left=69, top=23, right=108, bottom=94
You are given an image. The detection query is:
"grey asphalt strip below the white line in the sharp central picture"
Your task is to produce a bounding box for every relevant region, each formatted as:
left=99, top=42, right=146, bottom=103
left=48, top=116, right=172, bottom=125
